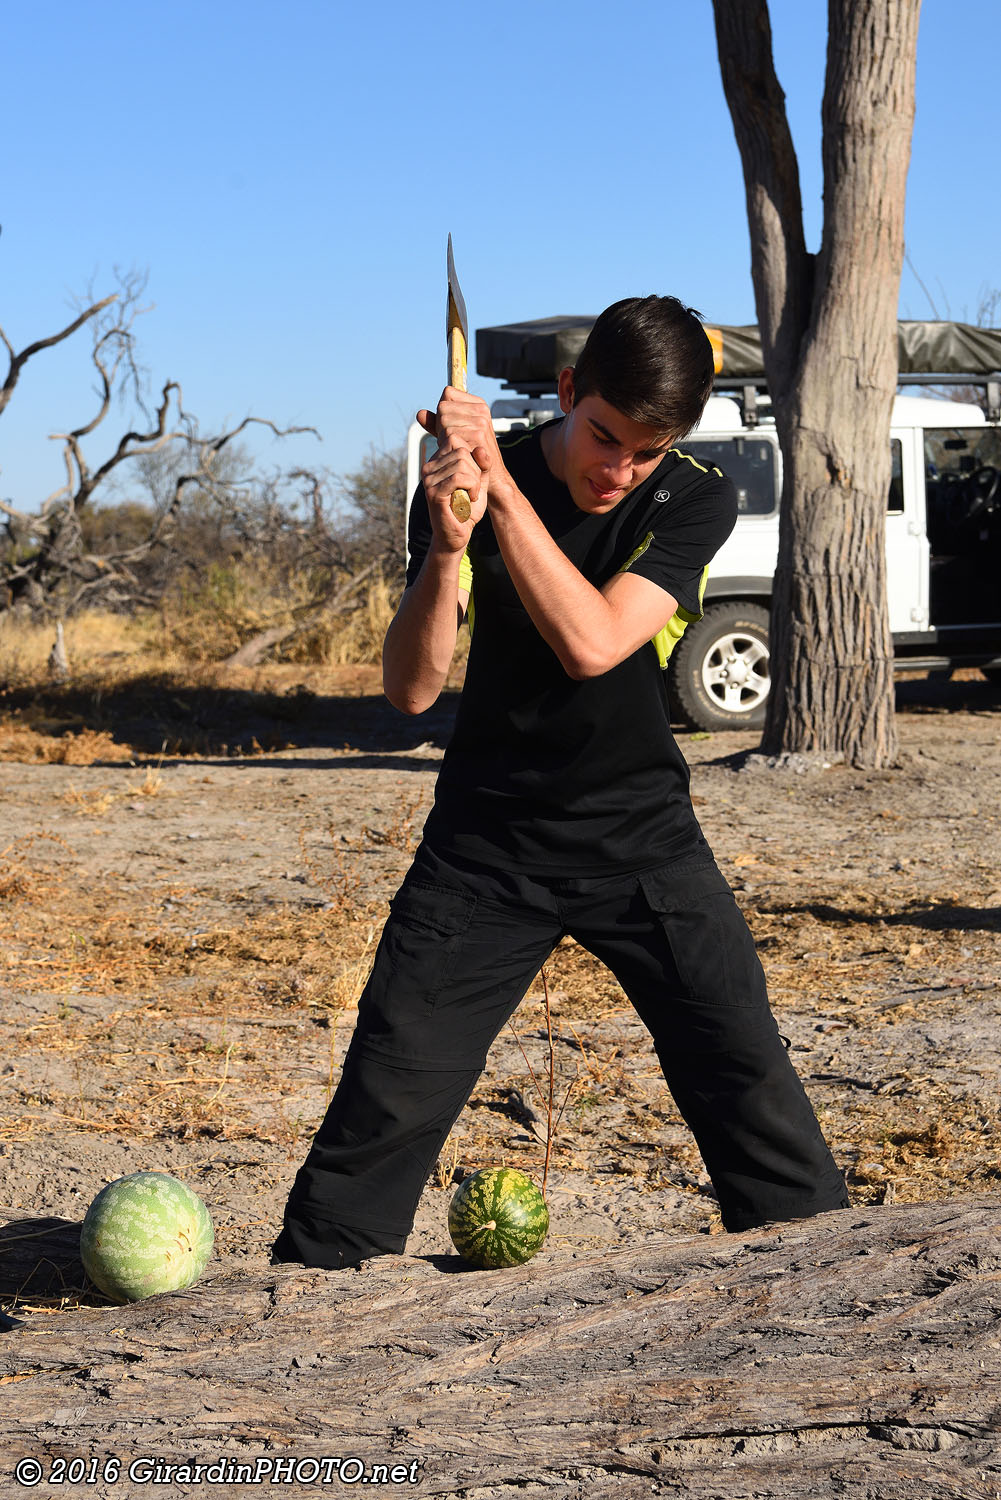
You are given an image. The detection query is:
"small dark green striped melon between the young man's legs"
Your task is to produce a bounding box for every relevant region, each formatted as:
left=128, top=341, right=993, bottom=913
left=449, top=1167, right=549, bottom=1271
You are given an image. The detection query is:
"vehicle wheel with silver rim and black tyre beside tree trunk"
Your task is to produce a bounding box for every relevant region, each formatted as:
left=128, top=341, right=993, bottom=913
left=671, top=603, right=770, bottom=731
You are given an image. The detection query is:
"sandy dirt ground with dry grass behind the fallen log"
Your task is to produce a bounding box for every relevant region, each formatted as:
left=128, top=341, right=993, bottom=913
left=0, top=669, right=1001, bottom=1305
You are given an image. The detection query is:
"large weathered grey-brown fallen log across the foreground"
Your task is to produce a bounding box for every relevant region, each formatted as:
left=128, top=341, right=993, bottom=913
left=0, top=1200, right=1001, bottom=1500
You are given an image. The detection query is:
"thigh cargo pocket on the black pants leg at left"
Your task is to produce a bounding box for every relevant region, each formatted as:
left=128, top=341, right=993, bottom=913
left=383, top=881, right=476, bottom=1010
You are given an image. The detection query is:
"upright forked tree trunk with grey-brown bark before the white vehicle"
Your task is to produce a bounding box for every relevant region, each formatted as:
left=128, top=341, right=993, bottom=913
left=714, top=0, right=920, bottom=767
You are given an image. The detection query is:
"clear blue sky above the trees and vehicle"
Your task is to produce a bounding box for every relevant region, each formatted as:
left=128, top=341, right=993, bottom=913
left=0, top=0, right=1001, bottom=510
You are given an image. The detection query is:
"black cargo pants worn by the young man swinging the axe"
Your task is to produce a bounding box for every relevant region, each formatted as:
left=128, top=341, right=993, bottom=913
left=273, top=845, right=848, bottom=1268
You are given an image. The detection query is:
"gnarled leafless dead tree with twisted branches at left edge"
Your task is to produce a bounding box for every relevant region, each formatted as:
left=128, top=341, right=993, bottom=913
left=0, top=273, right=315, bottom=612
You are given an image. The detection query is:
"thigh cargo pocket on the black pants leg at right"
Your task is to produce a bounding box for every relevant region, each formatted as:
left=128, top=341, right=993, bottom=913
left=639, top=861, right=768, bottom=1007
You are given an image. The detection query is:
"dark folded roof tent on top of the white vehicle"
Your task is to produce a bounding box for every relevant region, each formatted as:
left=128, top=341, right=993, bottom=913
left=476, top=317, right=1001, bottom=396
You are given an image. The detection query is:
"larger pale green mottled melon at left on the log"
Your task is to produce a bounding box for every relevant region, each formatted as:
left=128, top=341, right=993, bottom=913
left=80, top=1172, right=215, bottom=1302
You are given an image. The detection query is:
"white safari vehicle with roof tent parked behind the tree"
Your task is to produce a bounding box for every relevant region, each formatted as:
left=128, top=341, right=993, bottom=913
left=408, top=318, right=1001, bottom=731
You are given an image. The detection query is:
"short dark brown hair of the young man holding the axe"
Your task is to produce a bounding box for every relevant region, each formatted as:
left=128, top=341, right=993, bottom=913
left=573, top=297, right=714, bottom=441
